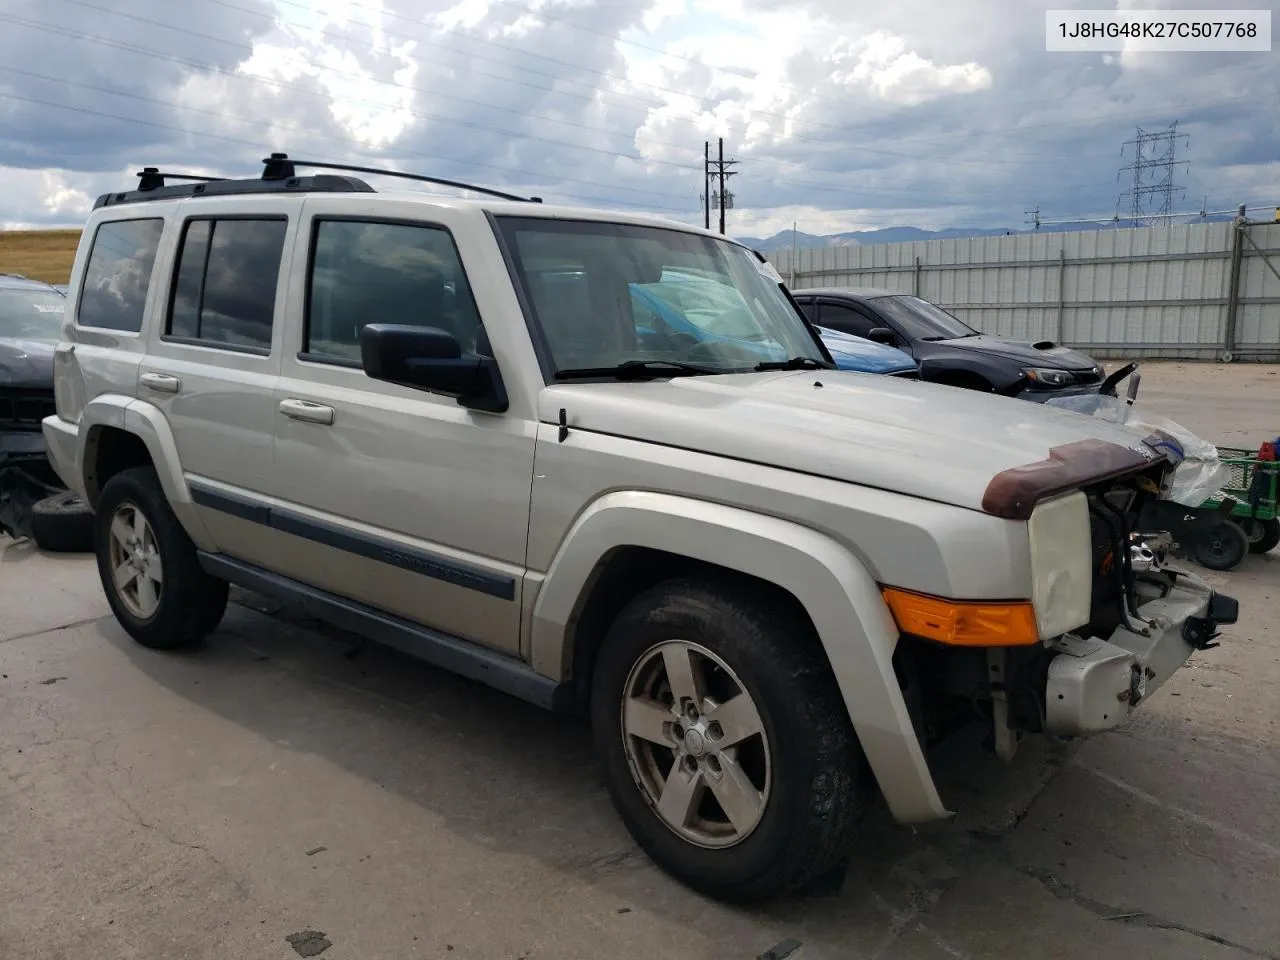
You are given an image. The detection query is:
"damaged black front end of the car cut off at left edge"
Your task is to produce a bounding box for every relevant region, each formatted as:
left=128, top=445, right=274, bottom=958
left=0, top=387, right=65, bottom=540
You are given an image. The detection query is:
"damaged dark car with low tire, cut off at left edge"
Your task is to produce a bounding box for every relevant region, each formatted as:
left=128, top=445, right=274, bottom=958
left=0, top=274, right=92, bottom=549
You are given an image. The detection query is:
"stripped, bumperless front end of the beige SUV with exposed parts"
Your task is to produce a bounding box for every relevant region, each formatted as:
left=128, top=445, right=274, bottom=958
left=895, top=438, right=1238, bottom=760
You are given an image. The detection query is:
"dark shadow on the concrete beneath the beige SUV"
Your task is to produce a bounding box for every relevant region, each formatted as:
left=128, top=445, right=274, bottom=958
left=100, top=591, right=1100, bottom=955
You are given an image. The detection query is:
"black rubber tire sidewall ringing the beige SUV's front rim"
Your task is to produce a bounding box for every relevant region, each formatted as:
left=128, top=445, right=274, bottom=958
left=591, top=578, right=860, bottom=899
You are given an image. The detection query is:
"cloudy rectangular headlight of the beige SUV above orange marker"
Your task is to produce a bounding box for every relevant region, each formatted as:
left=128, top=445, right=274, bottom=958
left=1027, top=492, right=1093, bottom=640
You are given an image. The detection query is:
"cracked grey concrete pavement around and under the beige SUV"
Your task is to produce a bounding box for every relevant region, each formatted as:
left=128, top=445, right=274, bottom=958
left=0, top=363, right=1280, bottom=960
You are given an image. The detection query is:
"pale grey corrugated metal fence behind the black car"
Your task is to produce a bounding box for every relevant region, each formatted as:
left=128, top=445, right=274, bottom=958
left=773, top=223, right=1280, bottom=360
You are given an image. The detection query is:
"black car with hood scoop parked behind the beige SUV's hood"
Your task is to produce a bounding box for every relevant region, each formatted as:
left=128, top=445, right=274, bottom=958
left=791, top=287, right=1105, bottom=401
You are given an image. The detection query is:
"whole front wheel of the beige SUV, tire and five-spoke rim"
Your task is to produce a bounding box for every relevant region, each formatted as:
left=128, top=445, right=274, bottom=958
left=591, top=580, right=867, bottom=902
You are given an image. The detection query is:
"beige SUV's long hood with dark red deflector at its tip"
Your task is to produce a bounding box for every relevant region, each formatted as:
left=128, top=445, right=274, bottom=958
left=539, top=370, right=1160, bottom=517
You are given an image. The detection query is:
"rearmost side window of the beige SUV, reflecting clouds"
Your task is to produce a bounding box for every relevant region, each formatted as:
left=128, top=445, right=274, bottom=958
left=76, top=218, right=164, bottom=333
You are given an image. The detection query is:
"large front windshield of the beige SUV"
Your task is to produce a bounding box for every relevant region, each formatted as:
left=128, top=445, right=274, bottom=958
left=499, top=218, right=826, bottom=374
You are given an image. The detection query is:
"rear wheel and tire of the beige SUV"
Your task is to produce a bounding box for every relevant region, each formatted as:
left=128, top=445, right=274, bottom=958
left=95, top=467, right=229, bottom=650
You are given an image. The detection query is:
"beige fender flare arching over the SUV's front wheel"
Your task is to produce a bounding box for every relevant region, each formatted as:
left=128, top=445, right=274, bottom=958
left=530, top=492, right=951, bottom=823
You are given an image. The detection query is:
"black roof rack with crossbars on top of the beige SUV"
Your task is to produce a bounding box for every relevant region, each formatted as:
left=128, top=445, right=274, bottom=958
left=93, top=154, right=543, bottom=210
